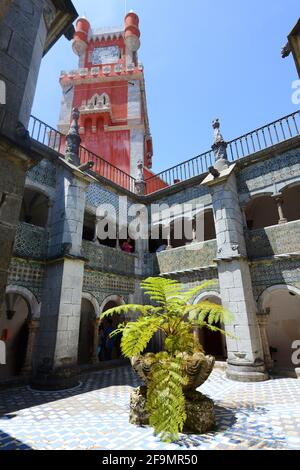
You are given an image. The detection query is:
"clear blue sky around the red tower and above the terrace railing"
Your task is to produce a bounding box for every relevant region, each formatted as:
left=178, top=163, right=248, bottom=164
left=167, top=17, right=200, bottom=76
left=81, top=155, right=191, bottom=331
left=33, top=0, right=299, bottom=172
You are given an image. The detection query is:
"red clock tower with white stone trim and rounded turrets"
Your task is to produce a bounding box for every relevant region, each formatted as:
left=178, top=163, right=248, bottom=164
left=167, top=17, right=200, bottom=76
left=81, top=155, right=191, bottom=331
left=59, top=12, right=153, bottom=177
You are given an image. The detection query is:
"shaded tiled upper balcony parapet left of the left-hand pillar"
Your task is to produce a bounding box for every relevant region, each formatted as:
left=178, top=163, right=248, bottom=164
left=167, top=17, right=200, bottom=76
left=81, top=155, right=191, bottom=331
left=14, top=222, right=49, bottom=260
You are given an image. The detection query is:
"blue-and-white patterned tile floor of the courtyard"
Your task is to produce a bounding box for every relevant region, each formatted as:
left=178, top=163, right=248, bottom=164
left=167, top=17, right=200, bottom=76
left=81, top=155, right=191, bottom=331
left=0, top=367, right=300, bottom=450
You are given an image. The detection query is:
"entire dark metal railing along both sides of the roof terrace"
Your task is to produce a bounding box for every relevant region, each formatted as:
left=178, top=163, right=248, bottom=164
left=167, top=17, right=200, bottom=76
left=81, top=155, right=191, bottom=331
left=29, top=111, right=300, bottom=194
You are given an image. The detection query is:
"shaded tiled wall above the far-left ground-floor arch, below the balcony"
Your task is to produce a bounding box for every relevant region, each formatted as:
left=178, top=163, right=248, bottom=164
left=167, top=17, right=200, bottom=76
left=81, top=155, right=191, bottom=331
left=8, top=258, right=45, bottom=302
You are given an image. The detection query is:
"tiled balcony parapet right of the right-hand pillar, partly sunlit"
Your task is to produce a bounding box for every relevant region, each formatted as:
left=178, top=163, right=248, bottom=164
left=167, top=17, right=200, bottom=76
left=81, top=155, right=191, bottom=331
left=246, top=220, right=300, bottom=259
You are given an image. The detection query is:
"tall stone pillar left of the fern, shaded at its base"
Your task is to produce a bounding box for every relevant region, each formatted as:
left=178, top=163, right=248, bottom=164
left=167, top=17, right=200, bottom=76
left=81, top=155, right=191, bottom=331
left=34, top=120, right=92, bottom=388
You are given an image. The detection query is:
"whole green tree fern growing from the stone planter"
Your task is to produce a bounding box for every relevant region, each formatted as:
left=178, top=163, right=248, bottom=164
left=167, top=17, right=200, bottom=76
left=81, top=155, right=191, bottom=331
left=101, top=277, right=233, bottom=441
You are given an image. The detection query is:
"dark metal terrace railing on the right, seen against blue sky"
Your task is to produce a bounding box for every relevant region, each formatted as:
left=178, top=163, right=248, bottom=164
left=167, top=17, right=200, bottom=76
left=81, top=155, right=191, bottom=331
left=146, top=111, right=300, bottom=194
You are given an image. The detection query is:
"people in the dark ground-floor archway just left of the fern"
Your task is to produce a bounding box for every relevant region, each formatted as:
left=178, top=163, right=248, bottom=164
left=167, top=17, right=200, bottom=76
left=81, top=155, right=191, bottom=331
left=97, top=318, right=121, bottom=361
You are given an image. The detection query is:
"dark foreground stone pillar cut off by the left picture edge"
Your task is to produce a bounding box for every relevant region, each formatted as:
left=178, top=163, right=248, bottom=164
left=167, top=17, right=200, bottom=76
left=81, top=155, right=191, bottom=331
left=0, top=0, right=74, bottom=315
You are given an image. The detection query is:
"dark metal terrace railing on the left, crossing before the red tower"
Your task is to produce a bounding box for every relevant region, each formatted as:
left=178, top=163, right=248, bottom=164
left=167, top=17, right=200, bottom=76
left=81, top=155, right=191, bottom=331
left=28, top=116, right=135, bottom=193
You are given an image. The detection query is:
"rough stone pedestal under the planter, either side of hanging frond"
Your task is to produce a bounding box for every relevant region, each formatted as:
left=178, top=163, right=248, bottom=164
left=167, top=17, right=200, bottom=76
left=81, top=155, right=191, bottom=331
left=129, top=387, right=216, bottom=434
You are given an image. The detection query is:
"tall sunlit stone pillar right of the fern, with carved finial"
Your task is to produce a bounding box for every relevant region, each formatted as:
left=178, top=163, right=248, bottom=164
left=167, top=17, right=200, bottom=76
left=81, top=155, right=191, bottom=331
left=202, top=120, right=268, bottom=381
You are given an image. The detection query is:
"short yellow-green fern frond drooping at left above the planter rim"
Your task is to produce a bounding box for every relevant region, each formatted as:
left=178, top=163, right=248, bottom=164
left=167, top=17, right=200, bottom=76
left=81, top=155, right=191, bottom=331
left=121, top=316, right=163, bottom=358
